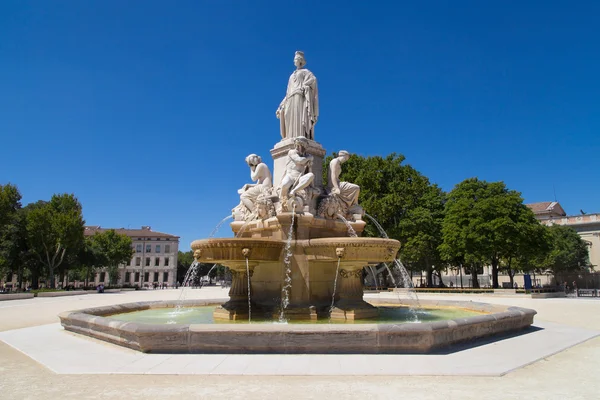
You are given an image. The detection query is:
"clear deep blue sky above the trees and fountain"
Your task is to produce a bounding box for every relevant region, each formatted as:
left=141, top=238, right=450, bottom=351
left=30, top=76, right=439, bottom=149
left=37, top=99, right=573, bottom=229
left=0, top=0, right=600, bottom=249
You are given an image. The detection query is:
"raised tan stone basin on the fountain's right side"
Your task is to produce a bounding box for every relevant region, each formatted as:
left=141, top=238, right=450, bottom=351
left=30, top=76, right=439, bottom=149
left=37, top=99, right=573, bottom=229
left=303, top=237, right=400, bottom=266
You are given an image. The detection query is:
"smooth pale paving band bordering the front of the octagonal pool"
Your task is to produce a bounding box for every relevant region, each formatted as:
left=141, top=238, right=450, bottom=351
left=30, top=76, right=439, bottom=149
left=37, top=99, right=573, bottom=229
left=0, top=321, right=600, bottom=376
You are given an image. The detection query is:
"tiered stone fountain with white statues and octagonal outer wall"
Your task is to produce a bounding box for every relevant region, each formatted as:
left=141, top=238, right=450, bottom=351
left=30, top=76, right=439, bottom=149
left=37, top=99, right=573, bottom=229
left=60, top=52, right=535, bottom=353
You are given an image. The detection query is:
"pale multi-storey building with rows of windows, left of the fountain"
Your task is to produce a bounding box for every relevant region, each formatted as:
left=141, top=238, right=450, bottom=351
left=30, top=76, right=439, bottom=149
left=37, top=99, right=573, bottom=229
left=84, top=226, right=179, bottom=288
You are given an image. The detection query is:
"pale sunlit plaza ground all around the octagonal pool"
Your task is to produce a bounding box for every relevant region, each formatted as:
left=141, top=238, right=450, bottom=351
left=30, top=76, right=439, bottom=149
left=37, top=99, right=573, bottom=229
left=0, top=287, right=600, bottom=399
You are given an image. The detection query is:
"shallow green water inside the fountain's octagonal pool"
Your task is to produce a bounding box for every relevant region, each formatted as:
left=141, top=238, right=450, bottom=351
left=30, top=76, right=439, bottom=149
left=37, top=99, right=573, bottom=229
left=110, top=306, right=481, bottom=324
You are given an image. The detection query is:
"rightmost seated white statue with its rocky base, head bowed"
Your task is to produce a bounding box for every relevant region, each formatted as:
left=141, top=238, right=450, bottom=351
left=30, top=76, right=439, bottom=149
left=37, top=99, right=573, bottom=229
left=319, top=150, right=363, bottom=219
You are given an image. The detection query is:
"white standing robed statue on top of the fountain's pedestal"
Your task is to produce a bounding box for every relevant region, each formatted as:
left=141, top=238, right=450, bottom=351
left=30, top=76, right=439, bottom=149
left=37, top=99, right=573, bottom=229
left=276, top=51, right=319, bottom=140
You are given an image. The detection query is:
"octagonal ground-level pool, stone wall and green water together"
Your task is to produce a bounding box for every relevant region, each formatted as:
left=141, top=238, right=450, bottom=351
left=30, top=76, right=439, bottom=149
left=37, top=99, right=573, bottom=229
left=60, top=300, right=536, bottom=354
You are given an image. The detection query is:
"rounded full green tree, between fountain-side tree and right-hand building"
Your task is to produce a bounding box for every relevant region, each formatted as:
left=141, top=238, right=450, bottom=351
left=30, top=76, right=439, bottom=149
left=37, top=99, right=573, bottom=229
left=440, top=178, right=538, bottom=288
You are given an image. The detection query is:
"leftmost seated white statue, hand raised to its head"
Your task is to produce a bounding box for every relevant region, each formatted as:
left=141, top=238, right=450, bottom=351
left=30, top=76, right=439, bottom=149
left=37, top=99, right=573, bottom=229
left=233, top=154, right=273, bottom=220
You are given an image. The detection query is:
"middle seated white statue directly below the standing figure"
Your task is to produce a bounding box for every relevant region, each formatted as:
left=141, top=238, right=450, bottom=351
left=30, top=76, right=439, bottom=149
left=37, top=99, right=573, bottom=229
left=279, top=136, right=315, bottom=210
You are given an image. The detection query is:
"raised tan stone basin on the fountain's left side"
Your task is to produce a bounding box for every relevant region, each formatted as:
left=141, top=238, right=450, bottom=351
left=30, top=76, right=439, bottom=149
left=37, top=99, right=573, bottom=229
left=191, top=238, right=285, bottom=264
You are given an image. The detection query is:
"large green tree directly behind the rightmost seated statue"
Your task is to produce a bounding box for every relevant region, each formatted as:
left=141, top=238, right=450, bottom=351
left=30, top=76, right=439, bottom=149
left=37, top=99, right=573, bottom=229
left=323, top=153, right=445, bottom=285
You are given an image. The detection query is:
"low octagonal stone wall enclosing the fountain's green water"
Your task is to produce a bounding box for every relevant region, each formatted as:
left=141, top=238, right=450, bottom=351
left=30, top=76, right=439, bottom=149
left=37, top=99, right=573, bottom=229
left=59, top=300, right=536, bottom=354
